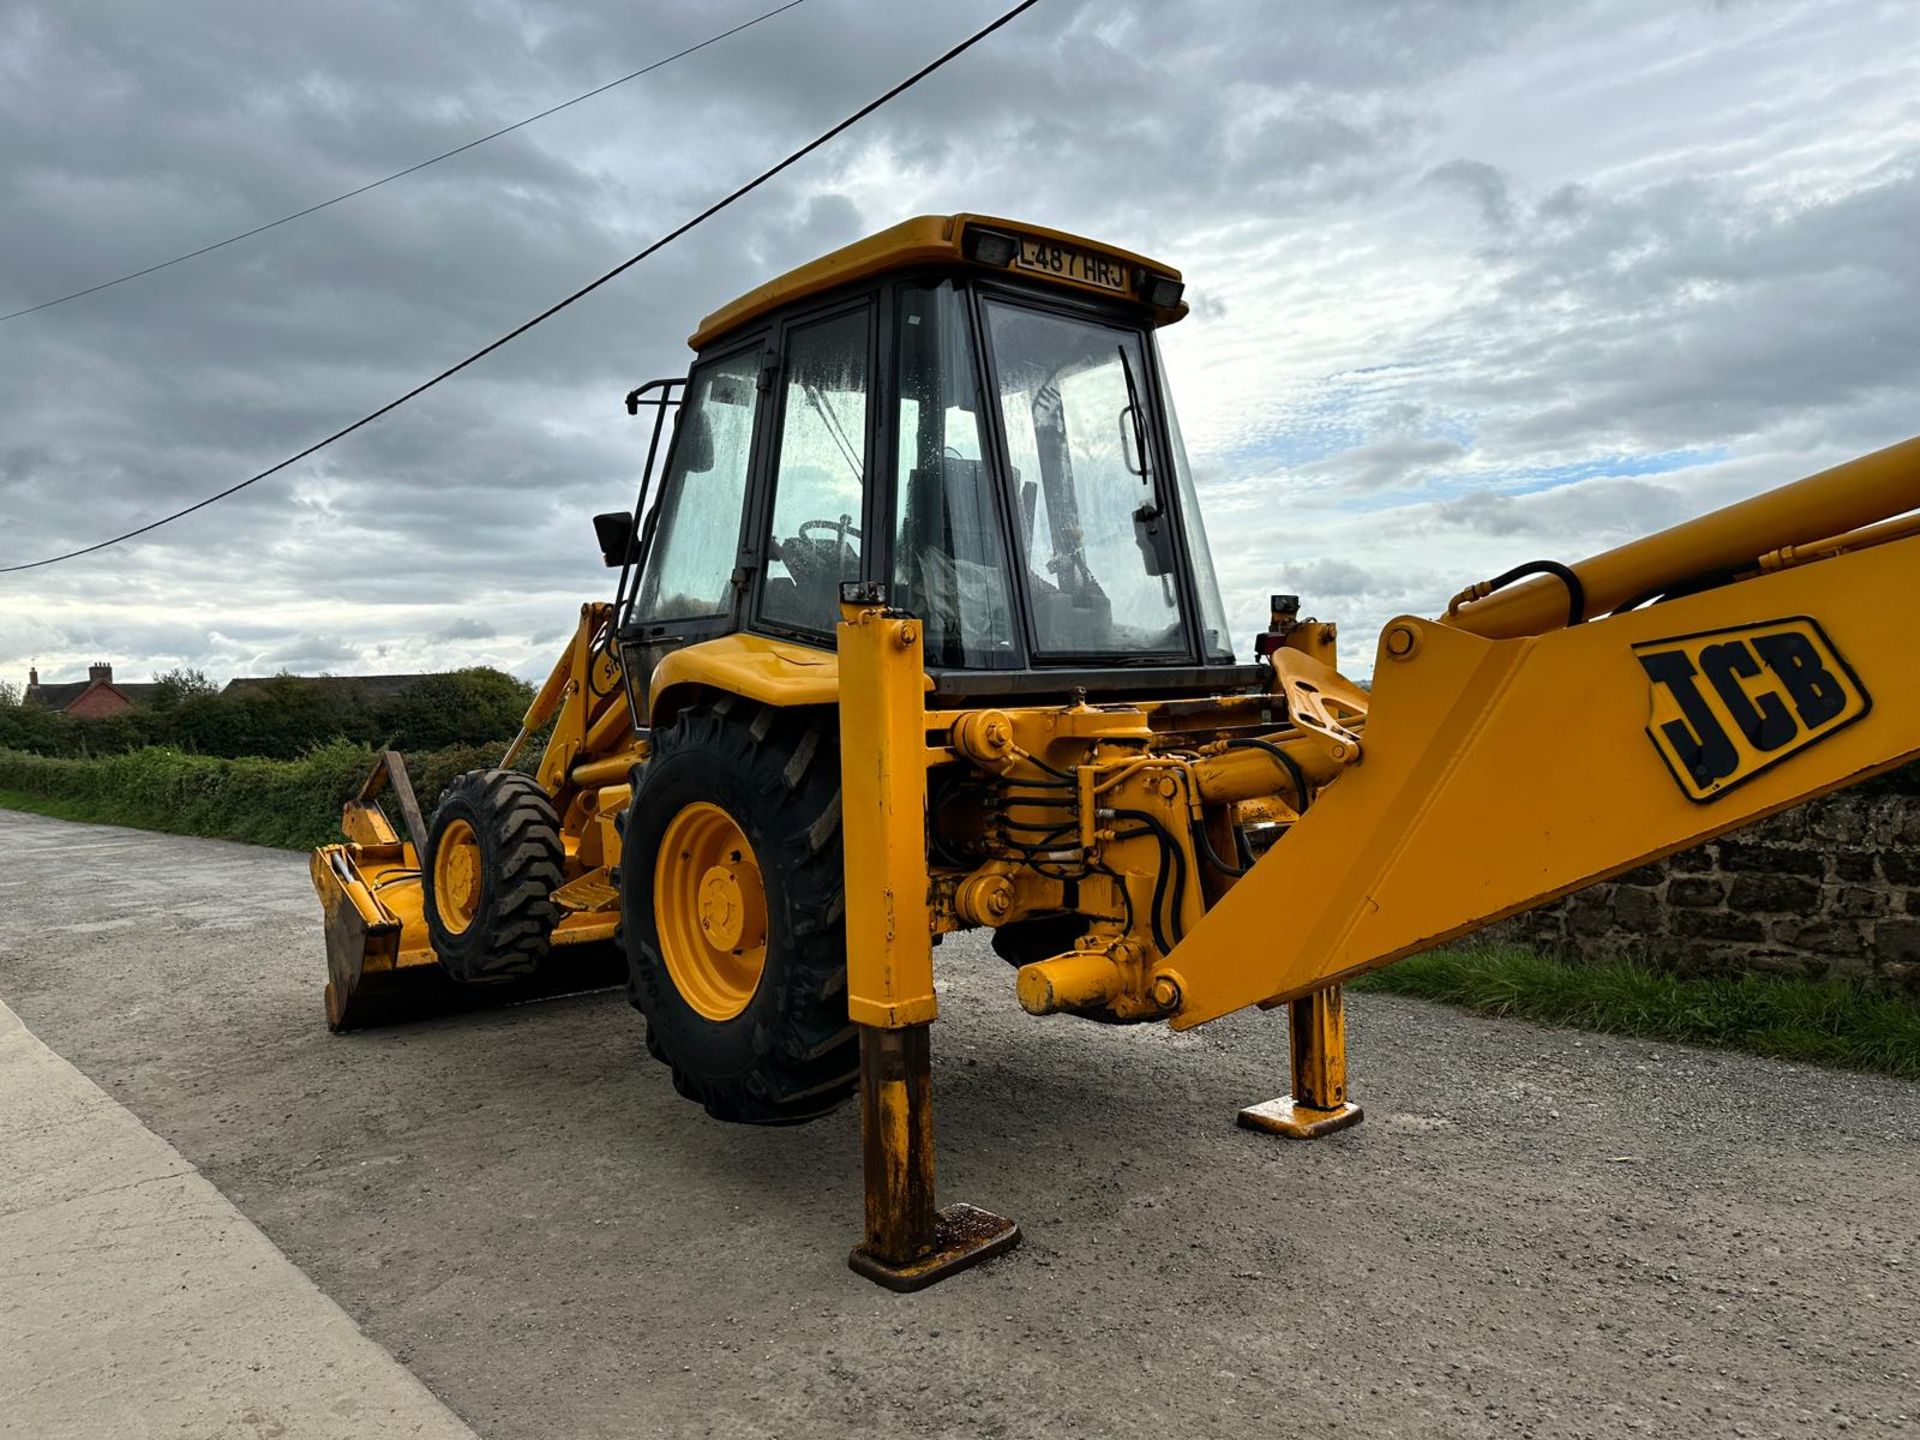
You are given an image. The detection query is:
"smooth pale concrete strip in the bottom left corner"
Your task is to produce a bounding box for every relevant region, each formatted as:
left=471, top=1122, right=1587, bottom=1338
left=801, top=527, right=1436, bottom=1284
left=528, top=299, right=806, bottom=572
left=0, top=1004, right=474, bottom=1440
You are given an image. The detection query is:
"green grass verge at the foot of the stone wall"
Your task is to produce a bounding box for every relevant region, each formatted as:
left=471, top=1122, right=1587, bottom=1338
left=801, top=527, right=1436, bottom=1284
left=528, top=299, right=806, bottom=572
left=1354, top=945, right=1920, bottom=1079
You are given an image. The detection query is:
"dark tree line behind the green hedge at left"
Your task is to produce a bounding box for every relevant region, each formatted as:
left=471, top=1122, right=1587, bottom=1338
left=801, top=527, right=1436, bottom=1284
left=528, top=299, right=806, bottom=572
left=0, top=666, right=534, bottom=760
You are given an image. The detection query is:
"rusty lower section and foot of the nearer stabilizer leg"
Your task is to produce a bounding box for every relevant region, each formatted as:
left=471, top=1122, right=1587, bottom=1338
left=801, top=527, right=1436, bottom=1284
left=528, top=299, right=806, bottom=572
left=847, top=1025, right=1020, bottom=1292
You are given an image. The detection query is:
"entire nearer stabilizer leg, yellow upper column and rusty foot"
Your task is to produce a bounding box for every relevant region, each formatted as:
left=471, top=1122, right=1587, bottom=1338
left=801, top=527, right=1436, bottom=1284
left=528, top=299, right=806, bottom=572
left=839, top=582, right=1020, bottom=1290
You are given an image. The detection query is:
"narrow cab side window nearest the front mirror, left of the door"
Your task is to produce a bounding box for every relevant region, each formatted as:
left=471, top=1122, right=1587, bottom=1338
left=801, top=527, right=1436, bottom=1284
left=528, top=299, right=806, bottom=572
left=634, top=349, right=760, bottom=624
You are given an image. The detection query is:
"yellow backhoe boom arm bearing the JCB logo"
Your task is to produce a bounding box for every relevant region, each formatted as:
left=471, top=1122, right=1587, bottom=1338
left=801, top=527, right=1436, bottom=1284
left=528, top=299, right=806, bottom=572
left=1158, top=440, right=1920, bottom=1029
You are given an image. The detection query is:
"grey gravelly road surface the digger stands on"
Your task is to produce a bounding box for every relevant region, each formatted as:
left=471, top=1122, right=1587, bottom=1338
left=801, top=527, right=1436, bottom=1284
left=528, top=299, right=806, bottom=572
left=0, top=812, right=1920, bottom=1440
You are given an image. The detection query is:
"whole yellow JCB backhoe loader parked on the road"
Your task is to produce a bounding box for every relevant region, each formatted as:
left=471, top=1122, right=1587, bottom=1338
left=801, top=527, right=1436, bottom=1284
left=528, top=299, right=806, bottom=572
left=313, top=215, right=1920, bottom=1288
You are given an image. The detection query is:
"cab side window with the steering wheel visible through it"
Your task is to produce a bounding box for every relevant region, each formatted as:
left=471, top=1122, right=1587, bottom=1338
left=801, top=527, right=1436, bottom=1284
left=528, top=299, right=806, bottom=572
left=760, top=309, right=870, bottom=634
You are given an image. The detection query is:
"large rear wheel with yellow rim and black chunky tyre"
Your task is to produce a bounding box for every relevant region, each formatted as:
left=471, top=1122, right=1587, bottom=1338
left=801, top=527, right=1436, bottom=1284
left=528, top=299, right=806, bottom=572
left=620, top=699, right=860, bottom=1125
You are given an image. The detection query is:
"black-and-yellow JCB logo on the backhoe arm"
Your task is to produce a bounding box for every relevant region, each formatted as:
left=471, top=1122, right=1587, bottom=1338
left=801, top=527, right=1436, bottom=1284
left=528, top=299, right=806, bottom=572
left=1634, top=616, right=1872, bottom=803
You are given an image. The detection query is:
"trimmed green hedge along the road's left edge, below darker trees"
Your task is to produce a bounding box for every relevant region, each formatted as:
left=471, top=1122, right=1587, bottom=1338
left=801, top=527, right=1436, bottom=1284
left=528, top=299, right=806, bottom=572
left=0, top=741, right=505, bottom=851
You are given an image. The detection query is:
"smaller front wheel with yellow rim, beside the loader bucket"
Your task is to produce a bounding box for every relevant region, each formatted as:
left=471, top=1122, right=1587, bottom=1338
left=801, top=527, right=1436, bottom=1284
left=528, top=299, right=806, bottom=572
left=420, top=770, right=564, bottom=985
